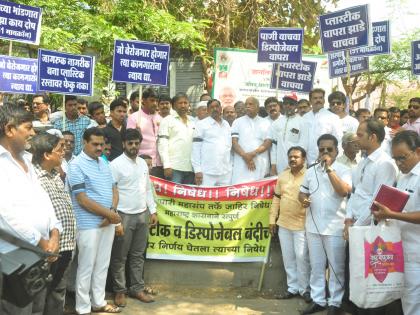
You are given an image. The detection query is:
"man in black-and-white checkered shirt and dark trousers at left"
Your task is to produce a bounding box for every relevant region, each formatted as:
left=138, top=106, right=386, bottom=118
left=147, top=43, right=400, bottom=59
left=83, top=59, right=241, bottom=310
left=32, top=130, right=76, bottom=315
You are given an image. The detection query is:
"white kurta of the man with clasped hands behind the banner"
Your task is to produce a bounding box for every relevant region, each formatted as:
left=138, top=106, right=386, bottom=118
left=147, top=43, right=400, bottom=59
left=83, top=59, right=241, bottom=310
left=232, top=115, right=270, bottom=184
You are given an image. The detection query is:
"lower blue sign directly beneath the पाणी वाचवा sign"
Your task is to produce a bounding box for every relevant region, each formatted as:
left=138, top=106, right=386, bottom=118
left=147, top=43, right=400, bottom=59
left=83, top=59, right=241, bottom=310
left=270, top=60, right=316, bottom=93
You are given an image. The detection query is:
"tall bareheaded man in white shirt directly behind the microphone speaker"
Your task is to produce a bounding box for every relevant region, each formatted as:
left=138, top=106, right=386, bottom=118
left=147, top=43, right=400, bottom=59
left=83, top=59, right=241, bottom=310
left=303, top=88, right=343, bottom=164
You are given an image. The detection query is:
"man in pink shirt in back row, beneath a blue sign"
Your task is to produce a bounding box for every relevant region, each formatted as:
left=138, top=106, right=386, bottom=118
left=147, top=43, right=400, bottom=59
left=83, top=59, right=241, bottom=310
left=127, top=88, right=164, bottom=178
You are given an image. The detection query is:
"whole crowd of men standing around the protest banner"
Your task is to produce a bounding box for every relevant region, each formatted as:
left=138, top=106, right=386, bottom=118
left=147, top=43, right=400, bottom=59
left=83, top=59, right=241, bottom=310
left=0, top=88, right=420, bottom=315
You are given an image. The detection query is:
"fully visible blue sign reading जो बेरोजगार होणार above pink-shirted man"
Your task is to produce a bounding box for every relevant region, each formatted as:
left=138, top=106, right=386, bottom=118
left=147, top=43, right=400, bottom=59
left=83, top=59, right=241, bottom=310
left=112, top=39, right=170, bottom=86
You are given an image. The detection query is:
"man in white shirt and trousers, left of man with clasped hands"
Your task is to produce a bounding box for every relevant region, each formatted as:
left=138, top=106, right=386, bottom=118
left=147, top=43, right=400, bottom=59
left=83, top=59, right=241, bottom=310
left=191, top=99, right=232, bottom=186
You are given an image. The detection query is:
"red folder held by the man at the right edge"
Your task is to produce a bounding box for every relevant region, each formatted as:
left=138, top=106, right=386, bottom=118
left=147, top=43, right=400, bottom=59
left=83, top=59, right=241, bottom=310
left=370, top=184, right=410, bottom=212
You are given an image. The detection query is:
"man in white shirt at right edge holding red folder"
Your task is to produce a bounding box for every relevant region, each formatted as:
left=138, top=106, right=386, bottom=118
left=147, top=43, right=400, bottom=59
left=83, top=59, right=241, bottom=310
left=374, top=130, right=420, bottom=315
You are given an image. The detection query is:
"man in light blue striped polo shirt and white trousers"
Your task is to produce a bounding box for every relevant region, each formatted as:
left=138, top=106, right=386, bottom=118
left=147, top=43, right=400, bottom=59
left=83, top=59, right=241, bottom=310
left=68, top=127, right=121, bottom=314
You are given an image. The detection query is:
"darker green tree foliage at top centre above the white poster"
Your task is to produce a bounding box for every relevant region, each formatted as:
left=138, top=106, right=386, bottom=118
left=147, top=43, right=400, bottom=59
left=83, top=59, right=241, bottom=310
left=146, top=0, right=338, bottom=89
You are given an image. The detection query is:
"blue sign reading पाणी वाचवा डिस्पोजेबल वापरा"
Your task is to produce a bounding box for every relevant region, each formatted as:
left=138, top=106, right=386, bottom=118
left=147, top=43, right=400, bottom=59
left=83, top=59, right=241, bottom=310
left=258, top=27, right=303, bottom=63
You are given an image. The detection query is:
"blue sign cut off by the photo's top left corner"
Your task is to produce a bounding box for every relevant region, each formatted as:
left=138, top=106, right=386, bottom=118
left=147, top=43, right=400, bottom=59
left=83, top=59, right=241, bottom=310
left=0, top=0, right=42, bottom=45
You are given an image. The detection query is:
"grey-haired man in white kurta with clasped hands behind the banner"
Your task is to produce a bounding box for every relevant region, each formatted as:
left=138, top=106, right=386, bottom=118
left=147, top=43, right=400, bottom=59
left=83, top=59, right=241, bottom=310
left=232, top=97, right=270, bottom=184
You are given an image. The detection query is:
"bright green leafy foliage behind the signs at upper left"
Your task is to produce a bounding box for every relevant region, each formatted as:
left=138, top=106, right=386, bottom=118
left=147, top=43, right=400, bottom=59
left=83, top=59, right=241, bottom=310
left=0, top=0, right=208, bottom=95
